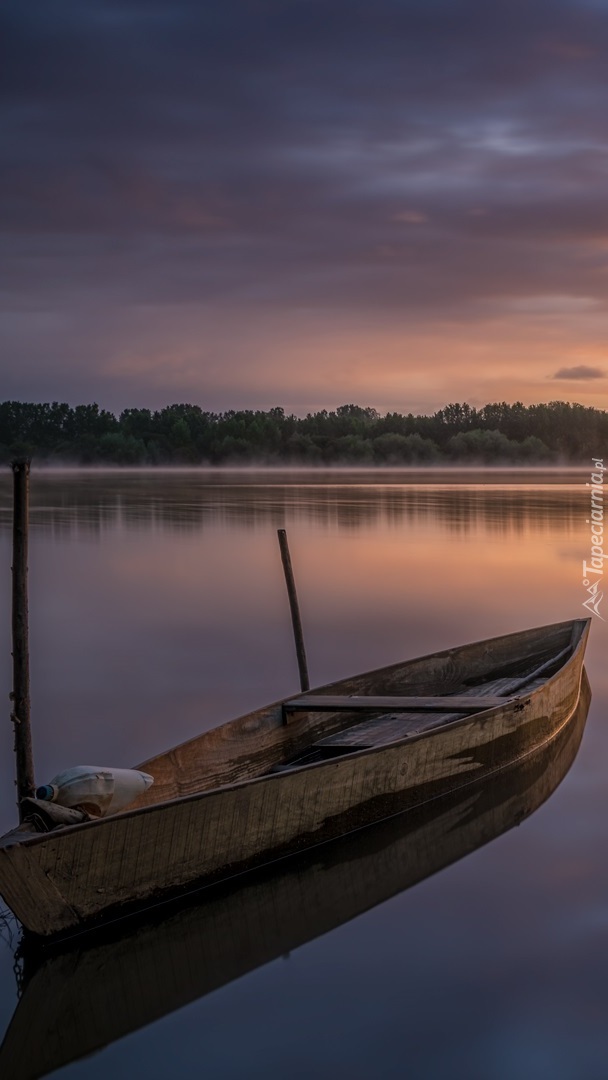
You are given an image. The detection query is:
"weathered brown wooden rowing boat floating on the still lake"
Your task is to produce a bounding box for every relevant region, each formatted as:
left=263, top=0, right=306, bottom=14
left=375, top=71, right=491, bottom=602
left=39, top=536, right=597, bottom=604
left=0, top=619, right=590, bottom=935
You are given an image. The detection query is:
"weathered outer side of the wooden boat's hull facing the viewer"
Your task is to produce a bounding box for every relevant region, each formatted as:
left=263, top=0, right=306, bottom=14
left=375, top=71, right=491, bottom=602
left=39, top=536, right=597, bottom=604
left=0, top=620, right=589, bottom=935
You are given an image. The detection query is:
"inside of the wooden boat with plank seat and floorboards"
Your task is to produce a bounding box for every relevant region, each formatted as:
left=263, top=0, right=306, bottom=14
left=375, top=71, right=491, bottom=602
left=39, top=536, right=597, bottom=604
left=129, top=619, right=589, bottom=809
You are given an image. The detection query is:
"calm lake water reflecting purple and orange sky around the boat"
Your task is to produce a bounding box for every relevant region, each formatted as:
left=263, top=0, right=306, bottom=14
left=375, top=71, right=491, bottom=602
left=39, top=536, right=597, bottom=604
left=0, top=470, right=608, bottom=1080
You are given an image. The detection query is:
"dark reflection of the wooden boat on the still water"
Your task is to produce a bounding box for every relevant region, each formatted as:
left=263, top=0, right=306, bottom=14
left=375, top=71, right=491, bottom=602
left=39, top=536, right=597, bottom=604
left=0, top=672, right=591, bottom=1080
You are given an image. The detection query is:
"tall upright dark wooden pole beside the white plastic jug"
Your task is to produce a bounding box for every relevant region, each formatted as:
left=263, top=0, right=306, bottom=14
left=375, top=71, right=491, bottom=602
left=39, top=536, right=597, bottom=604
left=11, top=458, right=36, bottom=820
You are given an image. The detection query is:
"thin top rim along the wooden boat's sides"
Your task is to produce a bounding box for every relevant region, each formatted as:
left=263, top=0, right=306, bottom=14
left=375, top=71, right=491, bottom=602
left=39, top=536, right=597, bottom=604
left=0, top=618, right=591, bottom=854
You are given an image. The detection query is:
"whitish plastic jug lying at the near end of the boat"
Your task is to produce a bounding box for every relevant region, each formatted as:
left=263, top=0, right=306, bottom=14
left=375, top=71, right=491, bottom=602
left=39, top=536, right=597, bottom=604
left=36, top=765, right=154, bottom=818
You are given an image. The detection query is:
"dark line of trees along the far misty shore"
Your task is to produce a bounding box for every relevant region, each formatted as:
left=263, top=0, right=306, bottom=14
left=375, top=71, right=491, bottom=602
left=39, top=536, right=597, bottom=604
left=0, top=402, right=608, bottom=465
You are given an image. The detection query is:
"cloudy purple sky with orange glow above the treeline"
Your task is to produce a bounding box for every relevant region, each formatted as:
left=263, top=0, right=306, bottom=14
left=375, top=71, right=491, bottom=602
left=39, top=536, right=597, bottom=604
left=0, top=0, right=608, bottom=414
